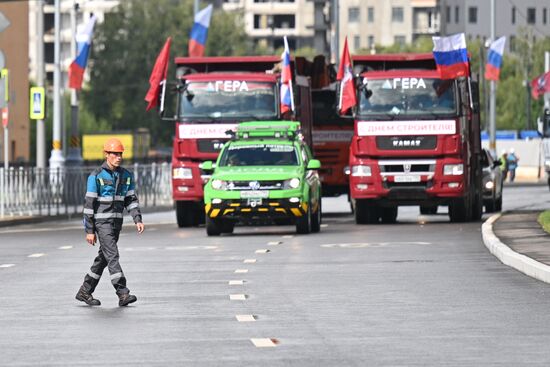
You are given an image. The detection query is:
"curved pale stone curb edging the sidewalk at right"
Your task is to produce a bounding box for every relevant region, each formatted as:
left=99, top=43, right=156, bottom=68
left=481, top=213, right=550, bottom=283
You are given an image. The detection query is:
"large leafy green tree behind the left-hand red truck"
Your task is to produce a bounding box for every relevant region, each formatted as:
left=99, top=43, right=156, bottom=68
left=81, top=0, right=250, bottom=145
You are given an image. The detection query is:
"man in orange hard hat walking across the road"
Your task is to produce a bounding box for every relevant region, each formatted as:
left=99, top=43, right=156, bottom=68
left=76, top=138, right=145, bottom=306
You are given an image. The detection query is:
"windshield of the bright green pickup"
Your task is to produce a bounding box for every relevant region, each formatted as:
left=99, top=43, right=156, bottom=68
left=219, top=144, right=298, bottom=167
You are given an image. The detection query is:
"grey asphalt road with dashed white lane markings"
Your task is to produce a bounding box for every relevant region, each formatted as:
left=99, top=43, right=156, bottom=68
left=0, top=186, right=550, bottom=366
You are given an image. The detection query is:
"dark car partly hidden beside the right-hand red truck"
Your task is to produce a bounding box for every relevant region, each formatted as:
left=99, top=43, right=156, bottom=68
left=481, top=149, right=502, bottom=213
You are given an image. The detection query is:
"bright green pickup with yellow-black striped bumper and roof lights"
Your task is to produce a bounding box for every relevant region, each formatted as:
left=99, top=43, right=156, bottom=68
left=202, top=121, right=321, bottom=236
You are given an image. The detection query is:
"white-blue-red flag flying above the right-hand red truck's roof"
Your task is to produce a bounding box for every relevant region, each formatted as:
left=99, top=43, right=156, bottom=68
left=432, top=33, right=470, bottom=79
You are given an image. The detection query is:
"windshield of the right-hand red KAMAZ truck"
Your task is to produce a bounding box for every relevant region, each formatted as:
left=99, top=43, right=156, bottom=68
left=359, top=78, right=456, bottom=116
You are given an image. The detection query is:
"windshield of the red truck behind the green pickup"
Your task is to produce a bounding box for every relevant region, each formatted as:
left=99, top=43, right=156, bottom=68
left=179, top=80, right=277, bottom=119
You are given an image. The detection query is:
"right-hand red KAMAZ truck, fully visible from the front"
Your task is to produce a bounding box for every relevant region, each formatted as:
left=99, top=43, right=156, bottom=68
left=349, top=53, right=483, bottom=224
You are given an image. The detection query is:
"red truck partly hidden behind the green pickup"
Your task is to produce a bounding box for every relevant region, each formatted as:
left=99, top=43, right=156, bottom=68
left=167, top=56, right=312, bottom=227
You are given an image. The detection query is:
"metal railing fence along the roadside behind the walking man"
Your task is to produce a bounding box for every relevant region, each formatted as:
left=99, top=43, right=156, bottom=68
left=0, top=163, right=172, bottom=219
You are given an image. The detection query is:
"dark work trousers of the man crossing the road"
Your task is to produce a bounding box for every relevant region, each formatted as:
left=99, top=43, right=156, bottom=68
left=82, top=220, right=130, bottom=294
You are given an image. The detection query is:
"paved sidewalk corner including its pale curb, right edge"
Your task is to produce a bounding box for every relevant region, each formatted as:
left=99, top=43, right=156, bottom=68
left=481, top=211, right=550, bottom=283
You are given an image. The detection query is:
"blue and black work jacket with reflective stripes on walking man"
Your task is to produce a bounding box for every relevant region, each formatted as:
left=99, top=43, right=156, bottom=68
left=83, top=162, right=141, bottom=233
